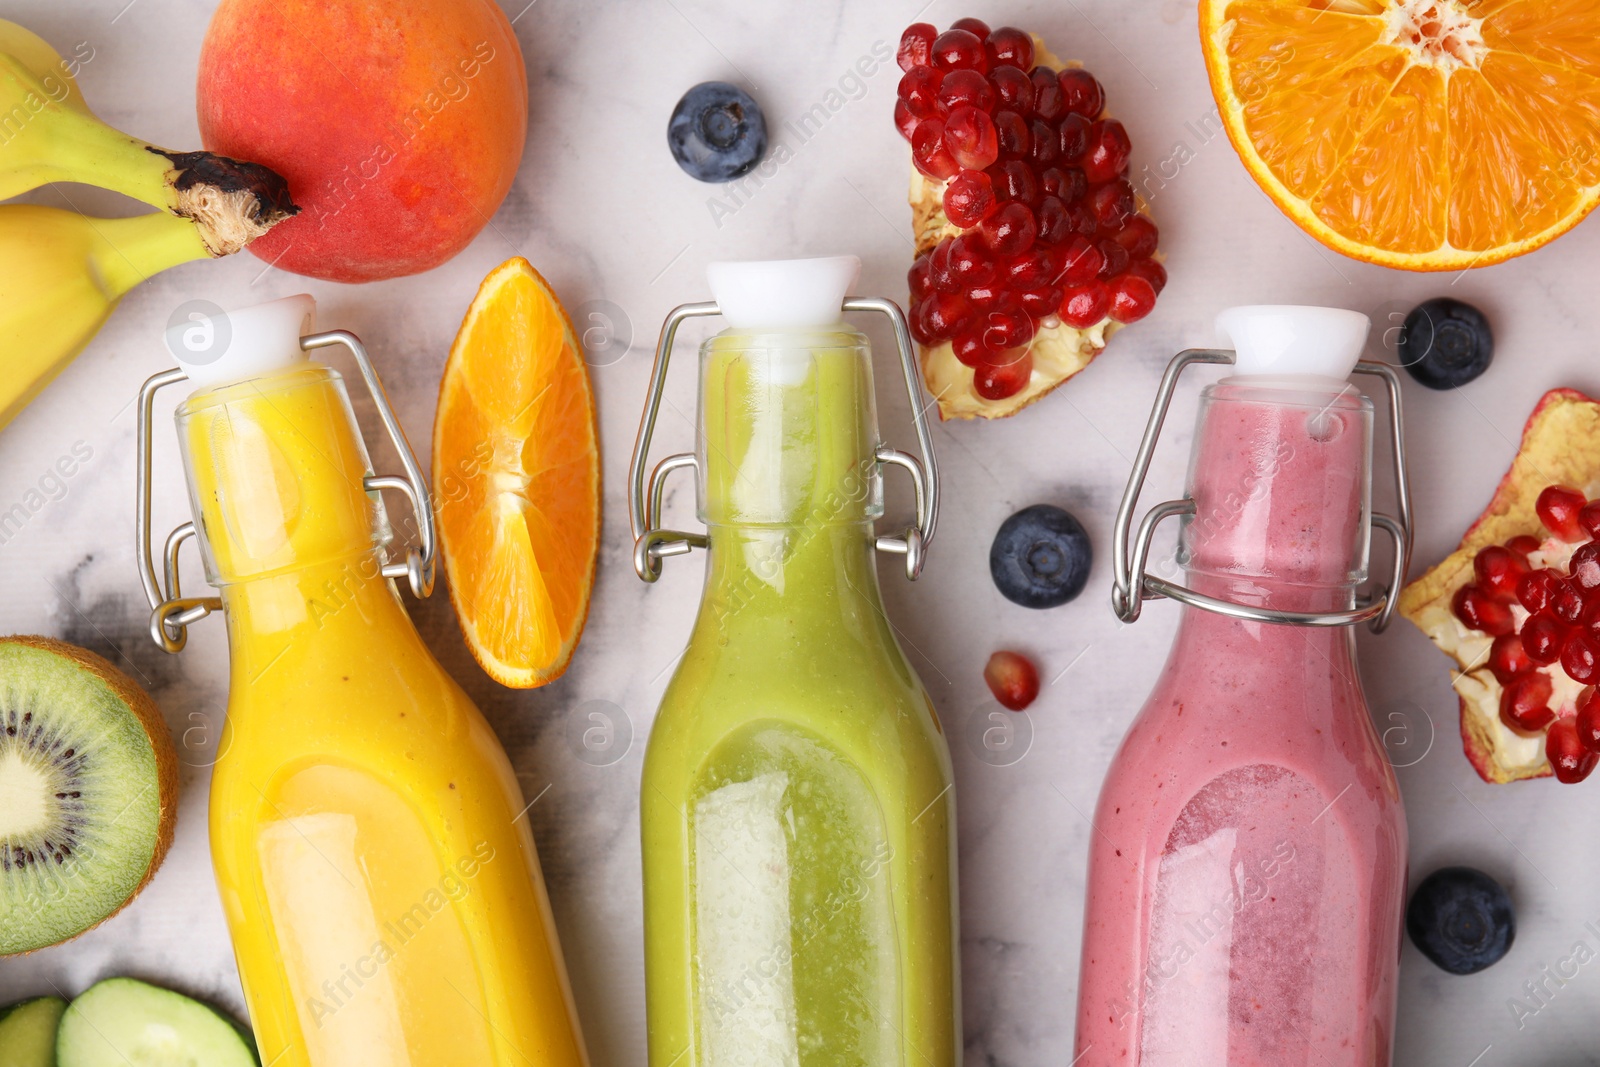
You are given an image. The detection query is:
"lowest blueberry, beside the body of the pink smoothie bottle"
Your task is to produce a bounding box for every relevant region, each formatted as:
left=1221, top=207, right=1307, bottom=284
left=1405, top=867, right=1517, bottom=974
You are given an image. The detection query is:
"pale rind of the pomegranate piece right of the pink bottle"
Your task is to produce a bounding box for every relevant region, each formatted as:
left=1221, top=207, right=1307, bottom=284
left=1398, top=389, right=1600, bottom=782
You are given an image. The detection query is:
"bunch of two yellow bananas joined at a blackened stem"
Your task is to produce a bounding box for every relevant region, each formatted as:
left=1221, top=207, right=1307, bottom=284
left=0, top=19, right=299, bottom=427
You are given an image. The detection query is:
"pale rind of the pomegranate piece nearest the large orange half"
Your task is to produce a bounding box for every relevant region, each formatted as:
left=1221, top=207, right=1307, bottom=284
left=907, top=34, right=1162, bottom=419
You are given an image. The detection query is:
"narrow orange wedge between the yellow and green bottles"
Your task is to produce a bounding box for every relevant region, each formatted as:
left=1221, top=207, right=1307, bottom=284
left=434, top=256, right=600, bottom=689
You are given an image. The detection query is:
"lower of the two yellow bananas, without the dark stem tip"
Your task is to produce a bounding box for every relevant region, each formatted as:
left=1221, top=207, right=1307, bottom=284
left=0, top=203, right=213, bottom=427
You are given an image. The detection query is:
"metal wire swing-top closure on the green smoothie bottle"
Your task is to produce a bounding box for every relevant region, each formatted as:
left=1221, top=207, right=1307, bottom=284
left=627, top=296, right=939, bottom=582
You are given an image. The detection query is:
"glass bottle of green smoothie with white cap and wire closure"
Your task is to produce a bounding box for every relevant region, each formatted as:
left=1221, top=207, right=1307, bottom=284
left=634, top=258, right=962, bottom=1067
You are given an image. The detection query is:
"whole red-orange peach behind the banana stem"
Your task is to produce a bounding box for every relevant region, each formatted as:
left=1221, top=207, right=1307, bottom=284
left=198, top=0, right=528, bottom=282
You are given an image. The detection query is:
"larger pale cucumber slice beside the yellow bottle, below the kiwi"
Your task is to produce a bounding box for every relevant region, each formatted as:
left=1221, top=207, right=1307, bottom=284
left=56, top=977, right=261, bottom=1067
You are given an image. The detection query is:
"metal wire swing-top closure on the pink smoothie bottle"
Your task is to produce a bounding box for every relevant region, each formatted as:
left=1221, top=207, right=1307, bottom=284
left=1110, top=349, right=1411, bottom=633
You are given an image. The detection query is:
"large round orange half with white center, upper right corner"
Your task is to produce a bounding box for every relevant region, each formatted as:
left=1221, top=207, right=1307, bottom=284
left=1200, top=0, right=1600, bottom=270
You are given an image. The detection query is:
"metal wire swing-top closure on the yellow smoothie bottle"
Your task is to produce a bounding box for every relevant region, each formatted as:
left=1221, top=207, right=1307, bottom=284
left=134, top=330, right=437, bottom=653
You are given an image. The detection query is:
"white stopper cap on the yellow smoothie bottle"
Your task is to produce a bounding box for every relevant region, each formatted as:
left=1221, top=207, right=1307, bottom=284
left=166, top=293, right=317, bottom=389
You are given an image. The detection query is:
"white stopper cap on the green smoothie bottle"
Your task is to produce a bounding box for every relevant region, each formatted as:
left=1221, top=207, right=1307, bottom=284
left=706, top=256, right=861, bottom=330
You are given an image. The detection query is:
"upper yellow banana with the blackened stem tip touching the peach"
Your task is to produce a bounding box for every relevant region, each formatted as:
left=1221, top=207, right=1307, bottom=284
left=0, top=19, right=299, bottom=256
